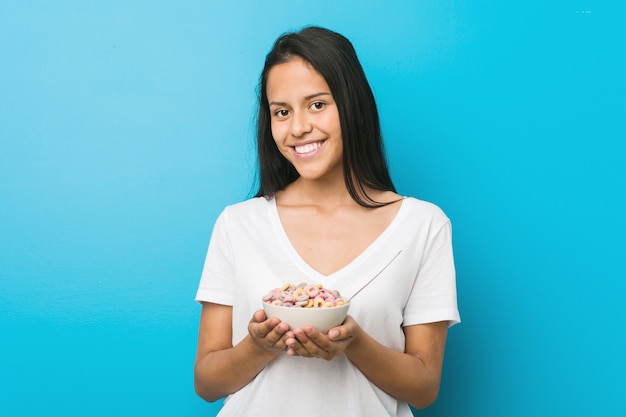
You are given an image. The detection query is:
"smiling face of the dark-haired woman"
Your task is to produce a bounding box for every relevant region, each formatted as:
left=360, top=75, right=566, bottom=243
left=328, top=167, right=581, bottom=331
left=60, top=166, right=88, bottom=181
left=266, top=58, right=343, bottom=180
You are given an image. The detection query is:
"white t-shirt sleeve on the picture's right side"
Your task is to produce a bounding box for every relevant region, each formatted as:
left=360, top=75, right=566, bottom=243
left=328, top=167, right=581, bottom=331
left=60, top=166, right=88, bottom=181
left=403, top=218, right=461, bottom=326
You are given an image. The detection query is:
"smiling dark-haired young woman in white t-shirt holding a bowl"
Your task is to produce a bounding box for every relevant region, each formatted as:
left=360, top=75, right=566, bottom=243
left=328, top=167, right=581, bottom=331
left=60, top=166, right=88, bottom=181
left=195, top=27, right=459, bottom=417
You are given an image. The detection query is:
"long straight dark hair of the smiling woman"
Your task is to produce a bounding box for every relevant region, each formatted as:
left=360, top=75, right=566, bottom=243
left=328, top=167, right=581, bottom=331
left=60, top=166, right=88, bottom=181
left=251, top=27, right=395, bottom=208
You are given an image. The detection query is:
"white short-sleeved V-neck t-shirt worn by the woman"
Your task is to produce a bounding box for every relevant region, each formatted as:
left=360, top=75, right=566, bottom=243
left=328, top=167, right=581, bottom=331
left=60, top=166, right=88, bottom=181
left=196, top=197, right=460, bottom=417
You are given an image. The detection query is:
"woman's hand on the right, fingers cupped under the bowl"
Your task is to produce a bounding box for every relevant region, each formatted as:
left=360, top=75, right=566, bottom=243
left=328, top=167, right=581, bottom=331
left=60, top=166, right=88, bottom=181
left=285, top=315, right=361, bottom=361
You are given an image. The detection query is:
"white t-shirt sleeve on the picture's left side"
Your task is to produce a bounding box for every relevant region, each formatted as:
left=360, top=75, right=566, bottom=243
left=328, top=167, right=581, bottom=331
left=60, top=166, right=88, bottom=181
left=196, top=210, right=235, bottom=306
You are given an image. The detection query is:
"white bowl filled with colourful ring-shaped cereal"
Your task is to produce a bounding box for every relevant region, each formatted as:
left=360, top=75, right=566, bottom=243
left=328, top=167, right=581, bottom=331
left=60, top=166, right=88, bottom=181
left=262, top=283, right=350, bottom=333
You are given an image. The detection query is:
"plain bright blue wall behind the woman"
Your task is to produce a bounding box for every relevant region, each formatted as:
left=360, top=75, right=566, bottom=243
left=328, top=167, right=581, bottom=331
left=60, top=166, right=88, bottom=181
left=0, top=0, right=626, bottom=417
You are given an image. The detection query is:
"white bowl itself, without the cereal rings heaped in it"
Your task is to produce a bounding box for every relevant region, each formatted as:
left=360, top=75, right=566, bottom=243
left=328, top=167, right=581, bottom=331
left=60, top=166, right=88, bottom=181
left=263, top=302, right=350, bottom=333
